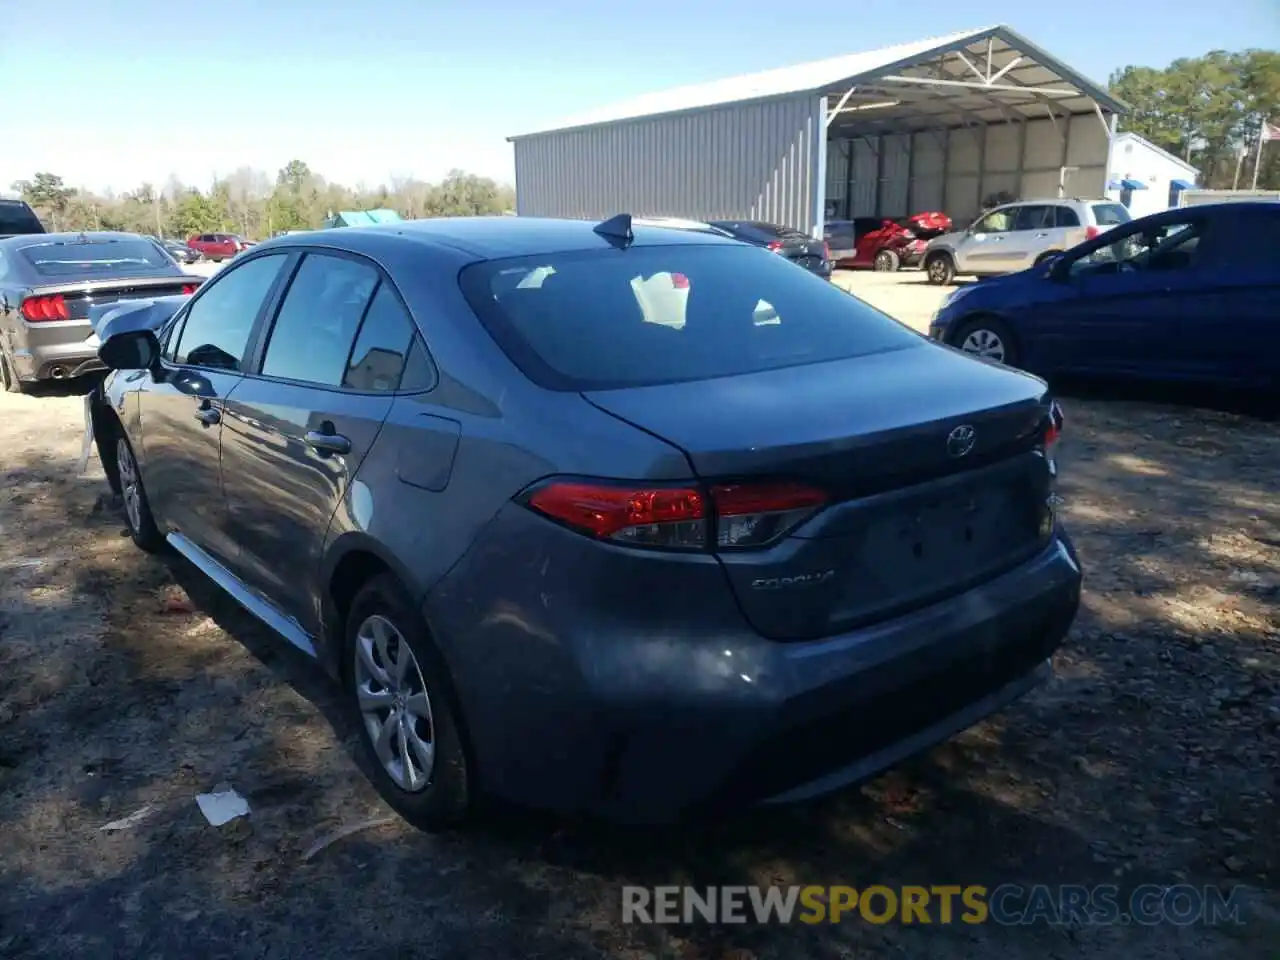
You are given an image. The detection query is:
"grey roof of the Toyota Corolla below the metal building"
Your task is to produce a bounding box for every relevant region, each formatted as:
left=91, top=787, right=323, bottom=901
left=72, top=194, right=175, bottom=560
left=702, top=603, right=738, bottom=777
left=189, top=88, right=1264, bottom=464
left=253, top=216, right=737, bottom=260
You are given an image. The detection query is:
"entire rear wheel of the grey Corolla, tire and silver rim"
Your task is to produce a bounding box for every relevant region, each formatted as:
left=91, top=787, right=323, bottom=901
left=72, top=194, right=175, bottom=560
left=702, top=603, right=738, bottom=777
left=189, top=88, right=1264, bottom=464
left=343, top=573, right=474, bottom=832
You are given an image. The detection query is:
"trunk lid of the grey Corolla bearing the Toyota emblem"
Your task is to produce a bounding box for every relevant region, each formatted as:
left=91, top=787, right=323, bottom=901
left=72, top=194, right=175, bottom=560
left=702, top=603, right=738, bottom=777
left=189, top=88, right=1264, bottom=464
left=584, top=344, right=1051, bottom=640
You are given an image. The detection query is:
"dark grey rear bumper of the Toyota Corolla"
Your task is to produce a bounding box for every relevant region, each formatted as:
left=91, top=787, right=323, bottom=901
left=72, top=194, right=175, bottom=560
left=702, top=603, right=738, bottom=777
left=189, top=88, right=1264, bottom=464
left=425, top=507, right=1082, bottom=823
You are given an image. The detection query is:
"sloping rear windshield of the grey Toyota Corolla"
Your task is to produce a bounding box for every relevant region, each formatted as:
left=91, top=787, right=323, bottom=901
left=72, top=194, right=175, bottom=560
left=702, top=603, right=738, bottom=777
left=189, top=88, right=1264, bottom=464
left=460, top=243, right=922, bottom=390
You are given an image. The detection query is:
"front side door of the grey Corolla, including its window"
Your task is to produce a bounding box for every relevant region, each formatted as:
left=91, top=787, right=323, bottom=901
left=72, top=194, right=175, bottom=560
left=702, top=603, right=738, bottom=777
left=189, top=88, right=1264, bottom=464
left=136, top=253, right=289, bottom=566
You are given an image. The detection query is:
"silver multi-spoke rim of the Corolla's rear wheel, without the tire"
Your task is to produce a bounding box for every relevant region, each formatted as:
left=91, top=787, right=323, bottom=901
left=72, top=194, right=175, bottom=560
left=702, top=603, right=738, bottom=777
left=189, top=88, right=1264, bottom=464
left=355, top=614, right=435, bottom=794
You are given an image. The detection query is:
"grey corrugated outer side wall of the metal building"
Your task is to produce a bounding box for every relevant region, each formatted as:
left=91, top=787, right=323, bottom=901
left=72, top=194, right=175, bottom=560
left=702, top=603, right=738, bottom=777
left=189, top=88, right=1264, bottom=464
left=513, top=95, right=829, bottom=232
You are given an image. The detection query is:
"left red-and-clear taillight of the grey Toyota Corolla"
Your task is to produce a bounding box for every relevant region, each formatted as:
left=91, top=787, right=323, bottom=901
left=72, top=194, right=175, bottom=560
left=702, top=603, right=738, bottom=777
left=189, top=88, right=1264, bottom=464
left=524, top=480, right=827, bottom=550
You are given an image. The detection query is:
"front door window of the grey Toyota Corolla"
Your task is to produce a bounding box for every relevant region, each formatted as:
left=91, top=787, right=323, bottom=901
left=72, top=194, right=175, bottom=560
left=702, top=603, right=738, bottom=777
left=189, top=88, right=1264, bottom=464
left=174, top=253, right=288, bottom=371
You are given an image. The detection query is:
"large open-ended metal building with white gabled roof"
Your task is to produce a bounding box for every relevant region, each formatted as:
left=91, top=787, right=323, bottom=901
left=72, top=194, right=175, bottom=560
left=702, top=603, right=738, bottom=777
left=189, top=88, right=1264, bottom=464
left=509, top=26, right=1126, bottom=236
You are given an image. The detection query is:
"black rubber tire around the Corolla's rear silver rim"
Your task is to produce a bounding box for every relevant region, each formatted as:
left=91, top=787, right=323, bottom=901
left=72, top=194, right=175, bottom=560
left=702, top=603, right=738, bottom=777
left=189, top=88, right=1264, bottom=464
left=342, top=573, right=476, bottom=832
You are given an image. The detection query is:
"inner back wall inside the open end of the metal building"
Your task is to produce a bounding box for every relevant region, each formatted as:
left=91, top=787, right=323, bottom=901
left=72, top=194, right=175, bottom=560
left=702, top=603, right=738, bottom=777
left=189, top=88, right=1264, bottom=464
left=827, top=114, right=1108, bottom=224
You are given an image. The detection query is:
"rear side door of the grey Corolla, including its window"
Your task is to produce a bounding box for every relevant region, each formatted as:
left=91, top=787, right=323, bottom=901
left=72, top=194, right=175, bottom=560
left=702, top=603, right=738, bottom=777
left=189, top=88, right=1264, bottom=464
left=223, top=251, right=410, bottom=632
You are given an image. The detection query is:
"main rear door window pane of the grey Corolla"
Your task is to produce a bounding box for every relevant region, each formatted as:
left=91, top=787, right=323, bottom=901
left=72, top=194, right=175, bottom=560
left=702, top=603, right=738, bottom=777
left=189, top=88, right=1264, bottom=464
left=262, top=253, right=379, bottom=387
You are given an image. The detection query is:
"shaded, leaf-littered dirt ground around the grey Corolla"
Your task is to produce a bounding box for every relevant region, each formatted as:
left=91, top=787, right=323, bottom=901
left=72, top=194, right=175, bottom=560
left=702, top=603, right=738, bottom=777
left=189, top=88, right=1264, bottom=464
left=0, top=278, right=1280, bottom=960
